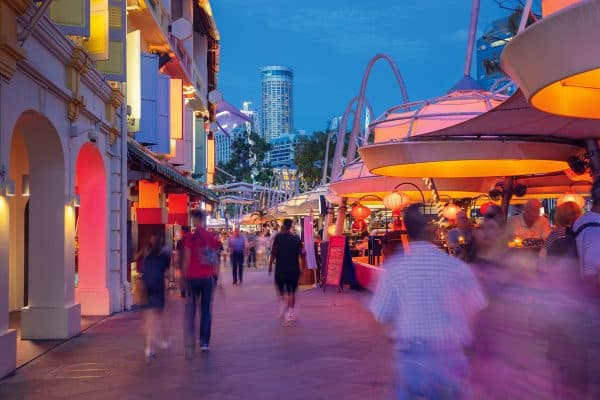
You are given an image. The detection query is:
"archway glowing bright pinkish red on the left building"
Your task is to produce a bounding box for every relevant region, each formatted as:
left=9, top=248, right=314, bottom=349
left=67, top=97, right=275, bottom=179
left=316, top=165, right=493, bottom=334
left=75, top=143, right=110, bottom=315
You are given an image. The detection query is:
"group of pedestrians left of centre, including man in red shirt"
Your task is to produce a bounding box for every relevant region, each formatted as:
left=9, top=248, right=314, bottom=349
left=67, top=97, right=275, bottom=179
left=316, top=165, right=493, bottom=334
left=137, top=216, right=305, bottom=361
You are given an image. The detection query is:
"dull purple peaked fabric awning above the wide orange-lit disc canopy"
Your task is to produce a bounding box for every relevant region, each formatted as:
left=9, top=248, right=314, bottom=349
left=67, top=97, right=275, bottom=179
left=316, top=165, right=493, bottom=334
left=413, top=90, right=600, bottom=140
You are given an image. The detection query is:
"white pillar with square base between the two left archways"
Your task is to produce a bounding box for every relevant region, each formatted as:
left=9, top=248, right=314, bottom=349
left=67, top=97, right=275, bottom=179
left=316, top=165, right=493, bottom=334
left=21, top=130, right=81, bottom=339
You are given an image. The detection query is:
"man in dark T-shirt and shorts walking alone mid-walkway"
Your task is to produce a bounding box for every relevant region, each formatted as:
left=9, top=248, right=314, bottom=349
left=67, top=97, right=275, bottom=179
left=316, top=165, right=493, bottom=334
left=269, top=219, right=305, bottom=325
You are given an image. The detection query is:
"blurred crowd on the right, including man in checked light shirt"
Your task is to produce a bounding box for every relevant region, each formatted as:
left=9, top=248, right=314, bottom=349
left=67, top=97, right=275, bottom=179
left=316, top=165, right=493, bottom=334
left=371, top=180, right=600, bottom=400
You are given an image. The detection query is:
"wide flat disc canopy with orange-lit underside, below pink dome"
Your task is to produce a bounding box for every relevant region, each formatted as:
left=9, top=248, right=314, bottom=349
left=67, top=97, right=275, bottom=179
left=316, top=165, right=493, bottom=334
left=359, top=138, right=582, bottom=178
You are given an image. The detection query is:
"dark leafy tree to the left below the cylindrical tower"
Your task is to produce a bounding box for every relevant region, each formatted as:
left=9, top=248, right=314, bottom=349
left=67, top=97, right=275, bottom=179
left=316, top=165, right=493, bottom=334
left=215, top=131, right=272, bottom=184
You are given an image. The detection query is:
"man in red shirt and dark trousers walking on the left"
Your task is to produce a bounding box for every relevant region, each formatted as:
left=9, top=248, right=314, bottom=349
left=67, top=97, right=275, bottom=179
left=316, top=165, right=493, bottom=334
left=183, top=210, right=219, bottom=360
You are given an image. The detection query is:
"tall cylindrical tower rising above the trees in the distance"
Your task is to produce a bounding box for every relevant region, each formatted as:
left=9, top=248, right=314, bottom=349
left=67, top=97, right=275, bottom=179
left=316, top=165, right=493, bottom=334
left=260, top=65, right=294, bottom=142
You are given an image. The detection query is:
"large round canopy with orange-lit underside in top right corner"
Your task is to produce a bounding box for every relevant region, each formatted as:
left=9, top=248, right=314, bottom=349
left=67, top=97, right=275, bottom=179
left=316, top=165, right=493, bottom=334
left=502, top=1, right=600, bottom=119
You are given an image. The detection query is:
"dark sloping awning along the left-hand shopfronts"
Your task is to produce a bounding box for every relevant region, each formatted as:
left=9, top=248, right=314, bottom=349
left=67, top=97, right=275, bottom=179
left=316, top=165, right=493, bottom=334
left=127, top=141, right=219, bottom=203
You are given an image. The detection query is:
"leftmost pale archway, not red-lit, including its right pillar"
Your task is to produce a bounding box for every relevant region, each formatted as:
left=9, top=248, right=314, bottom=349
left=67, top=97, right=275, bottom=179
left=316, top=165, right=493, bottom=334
left=8, top=111, right=81, bottom=339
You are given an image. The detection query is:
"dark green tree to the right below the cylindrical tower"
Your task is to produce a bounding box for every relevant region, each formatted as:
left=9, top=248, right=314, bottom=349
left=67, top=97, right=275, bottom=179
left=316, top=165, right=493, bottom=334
left=294, top=131, right=335, bottom=188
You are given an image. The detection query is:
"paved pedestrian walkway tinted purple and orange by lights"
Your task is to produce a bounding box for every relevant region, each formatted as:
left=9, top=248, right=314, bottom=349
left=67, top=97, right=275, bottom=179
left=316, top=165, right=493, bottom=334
left=0, top=271, right=393, bottom=400
